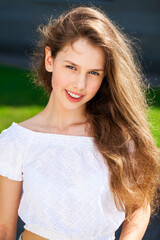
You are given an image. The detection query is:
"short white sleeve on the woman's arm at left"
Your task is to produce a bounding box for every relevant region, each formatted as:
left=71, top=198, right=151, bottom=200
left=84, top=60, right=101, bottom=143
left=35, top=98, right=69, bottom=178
left=0, top=129, right=23, bottom=181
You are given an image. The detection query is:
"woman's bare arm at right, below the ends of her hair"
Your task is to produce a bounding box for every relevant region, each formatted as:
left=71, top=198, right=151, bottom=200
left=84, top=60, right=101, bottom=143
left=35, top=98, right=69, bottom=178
left=119, top=204, right=150, bottom=240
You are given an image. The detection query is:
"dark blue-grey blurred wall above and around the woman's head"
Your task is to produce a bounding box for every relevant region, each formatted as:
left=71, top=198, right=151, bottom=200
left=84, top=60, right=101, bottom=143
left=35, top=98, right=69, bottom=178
left=0, top=0, right=160, bottom=72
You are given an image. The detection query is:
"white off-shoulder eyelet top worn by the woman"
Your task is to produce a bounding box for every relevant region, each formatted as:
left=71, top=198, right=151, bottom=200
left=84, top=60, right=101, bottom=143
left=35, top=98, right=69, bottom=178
left=0, top=122, right=125, bottom=240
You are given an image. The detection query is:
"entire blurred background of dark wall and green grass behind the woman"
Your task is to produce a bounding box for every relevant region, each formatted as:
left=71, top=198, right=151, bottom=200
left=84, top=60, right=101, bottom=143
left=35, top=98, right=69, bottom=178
left=0, top=0, right=160, bottom=240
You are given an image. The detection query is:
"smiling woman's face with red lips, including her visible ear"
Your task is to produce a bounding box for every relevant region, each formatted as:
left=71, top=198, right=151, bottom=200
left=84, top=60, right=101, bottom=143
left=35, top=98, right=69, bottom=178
left=45, top=39, right=105, bottom=110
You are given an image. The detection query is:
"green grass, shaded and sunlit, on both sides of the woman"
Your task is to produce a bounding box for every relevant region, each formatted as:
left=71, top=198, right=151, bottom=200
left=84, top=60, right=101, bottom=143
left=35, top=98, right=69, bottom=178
left=0, top=65, right=160, bottom=147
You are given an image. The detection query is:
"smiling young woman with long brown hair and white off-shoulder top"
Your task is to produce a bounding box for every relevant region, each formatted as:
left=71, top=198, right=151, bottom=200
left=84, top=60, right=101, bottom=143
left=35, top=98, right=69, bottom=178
left=0, top=7, right=159, bottom=240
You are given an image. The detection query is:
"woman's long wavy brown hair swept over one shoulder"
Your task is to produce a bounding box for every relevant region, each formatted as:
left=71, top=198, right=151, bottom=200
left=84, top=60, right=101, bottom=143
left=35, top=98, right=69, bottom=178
left=29, top=6, right=159, bottom=217
